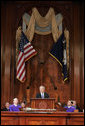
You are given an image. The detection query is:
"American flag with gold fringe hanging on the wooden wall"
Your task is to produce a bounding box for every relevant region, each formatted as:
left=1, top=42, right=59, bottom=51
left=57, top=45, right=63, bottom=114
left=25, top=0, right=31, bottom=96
left=16, top=32, right=37, bottom=82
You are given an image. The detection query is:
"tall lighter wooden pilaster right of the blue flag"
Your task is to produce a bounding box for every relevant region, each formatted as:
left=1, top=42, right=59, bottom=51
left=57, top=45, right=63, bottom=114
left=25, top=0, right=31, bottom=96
left=74, top=4, right=80, bottom=102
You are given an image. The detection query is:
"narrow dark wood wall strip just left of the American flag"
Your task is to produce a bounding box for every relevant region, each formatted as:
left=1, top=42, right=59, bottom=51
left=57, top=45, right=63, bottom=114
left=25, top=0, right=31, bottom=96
left=9, top=4, right=16, bottom=103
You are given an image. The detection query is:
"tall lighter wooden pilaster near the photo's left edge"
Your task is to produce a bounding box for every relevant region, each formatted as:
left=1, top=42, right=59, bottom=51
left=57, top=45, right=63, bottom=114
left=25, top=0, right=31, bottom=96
left=4, top=4, right=12, bottom=102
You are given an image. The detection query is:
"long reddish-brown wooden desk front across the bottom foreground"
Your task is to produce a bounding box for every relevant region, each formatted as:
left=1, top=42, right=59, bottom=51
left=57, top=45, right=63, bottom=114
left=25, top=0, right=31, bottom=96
left=1, top=111, right=84, bottom=125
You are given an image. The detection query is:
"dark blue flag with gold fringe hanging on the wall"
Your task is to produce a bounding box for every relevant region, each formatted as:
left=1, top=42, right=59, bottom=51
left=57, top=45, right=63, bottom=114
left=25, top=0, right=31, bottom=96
left=49, top=32, right=68, bottom=81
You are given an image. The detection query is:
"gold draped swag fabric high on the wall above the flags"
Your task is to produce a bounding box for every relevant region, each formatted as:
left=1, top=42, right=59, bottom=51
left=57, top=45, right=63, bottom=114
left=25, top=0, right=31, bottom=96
left=25, top=8, right=63, bottom=42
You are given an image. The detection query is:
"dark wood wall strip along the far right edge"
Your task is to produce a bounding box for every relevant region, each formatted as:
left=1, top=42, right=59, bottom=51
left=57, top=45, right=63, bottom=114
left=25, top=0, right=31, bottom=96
left=80, top=2, right=84, bottom=109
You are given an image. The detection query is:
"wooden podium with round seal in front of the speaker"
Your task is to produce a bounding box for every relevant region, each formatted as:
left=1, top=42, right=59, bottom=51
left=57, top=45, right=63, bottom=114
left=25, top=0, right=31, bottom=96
left=30, top=98, right=55, bottom=109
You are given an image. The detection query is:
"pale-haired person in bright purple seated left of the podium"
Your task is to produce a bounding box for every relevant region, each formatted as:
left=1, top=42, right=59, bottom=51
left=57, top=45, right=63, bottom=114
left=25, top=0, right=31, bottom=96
left=9, top=98, right=21, bottom=111
